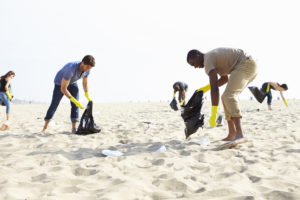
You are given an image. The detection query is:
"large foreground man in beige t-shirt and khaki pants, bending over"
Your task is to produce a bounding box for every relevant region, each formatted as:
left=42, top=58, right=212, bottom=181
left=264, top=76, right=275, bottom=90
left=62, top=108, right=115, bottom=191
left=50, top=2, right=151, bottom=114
left=187, top=48, right=257, bottom=141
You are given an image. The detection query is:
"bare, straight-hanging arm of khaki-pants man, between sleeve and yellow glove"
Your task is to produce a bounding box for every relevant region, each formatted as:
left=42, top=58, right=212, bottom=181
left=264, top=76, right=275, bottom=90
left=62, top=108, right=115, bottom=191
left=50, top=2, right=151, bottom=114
left=208, top=69, right=218, bottom=106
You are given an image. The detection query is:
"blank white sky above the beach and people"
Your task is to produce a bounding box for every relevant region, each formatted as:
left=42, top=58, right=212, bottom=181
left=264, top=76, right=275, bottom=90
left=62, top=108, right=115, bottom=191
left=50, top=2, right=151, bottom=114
left=0, top=0, right=300, bottom=102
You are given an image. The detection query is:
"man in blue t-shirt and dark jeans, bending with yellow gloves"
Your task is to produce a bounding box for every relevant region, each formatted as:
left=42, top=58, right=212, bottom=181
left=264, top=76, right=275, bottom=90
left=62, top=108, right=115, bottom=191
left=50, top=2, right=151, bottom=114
left=43, top=55, right=95, bottom=133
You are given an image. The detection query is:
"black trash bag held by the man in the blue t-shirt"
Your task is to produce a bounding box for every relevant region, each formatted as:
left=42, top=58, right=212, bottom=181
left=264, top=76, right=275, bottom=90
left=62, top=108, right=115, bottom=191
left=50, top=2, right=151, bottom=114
left=76, top=101, right=101, bottom=135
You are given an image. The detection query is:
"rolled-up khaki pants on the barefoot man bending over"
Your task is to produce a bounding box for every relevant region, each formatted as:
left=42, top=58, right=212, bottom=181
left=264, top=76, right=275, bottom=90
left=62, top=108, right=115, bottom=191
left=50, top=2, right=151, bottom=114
left=222, top=59, right=257, bottom=120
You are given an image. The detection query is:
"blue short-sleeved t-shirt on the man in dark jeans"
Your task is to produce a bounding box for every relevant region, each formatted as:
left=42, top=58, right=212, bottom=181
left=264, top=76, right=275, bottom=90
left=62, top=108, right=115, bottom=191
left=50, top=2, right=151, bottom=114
left=54, top=61, right=90, bottom=85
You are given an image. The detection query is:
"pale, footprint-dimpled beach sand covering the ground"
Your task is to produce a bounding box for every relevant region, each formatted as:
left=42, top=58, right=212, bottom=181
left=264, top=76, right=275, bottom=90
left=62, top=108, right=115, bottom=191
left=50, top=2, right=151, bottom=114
left=0, top=100, right=300, bottom=200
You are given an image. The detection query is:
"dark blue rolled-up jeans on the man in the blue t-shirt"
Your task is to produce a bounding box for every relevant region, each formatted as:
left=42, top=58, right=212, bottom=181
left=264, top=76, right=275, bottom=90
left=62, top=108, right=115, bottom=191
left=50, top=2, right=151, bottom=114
left=45, top=84, right=79, bottom=122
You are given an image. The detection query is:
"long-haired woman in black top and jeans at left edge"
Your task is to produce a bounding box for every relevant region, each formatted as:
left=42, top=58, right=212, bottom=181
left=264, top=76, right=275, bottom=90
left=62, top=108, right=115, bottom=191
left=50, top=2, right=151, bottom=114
left=0, top=71, right=15, bottom=131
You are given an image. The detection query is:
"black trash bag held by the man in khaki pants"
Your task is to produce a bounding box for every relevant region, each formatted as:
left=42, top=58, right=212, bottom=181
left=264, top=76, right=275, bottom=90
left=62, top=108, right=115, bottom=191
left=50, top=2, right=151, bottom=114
left=181, top=91, right=204, bottom=139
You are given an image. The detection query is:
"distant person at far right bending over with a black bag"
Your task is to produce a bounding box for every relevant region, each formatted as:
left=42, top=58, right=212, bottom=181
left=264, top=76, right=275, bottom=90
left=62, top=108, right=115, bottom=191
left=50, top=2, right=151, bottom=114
left=249, top=82, right=288, bottom=110
